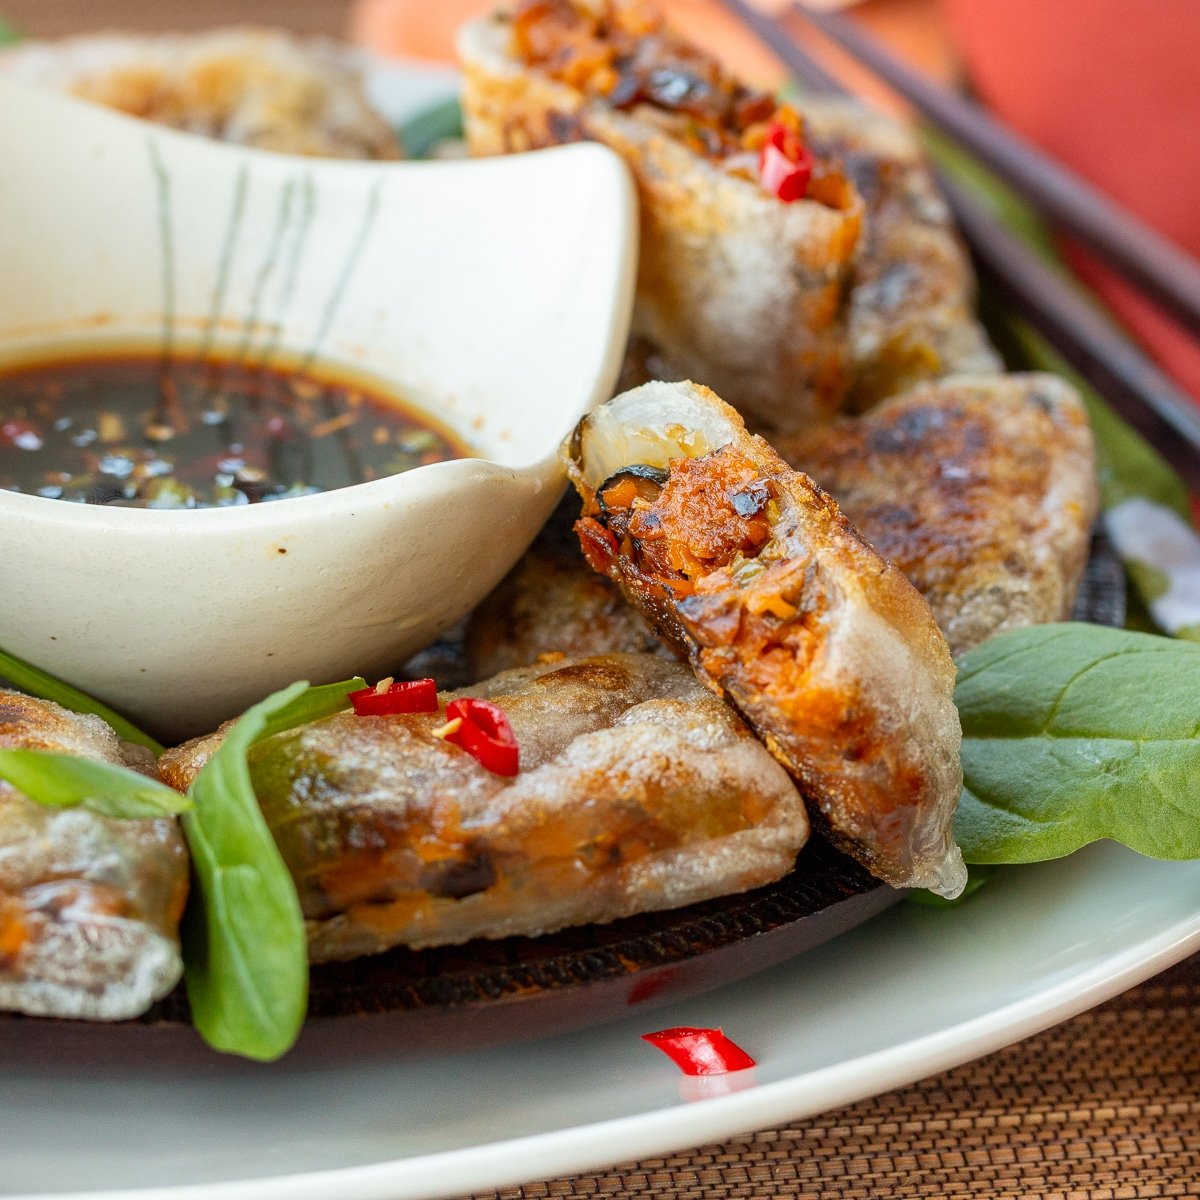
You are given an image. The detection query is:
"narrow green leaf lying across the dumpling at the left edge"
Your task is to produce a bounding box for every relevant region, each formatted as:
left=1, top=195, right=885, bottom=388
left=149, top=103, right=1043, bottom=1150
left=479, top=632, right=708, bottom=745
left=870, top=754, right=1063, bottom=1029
left=0, top=750, right=192, bottom=820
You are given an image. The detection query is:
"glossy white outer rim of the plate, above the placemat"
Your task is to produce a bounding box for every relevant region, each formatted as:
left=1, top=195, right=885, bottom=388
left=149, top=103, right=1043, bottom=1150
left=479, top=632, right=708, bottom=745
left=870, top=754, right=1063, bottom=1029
left=9, top=847, right=1200, bottom=1200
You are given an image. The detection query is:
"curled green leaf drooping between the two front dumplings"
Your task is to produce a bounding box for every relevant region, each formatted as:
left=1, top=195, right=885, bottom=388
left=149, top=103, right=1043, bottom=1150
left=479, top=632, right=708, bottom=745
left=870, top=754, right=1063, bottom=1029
left=184, top=679, right=365, bottom=1062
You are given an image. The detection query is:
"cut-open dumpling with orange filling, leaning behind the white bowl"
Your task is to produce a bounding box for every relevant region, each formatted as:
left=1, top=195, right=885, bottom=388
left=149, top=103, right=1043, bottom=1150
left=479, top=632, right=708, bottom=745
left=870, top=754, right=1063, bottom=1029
left=458, top=0, right=862, bottom=428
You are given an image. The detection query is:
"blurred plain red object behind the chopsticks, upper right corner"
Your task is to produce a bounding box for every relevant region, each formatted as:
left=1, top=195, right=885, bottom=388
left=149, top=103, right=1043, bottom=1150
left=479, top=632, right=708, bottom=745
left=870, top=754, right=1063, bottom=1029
left=944, top=0, right=1200, bottom=397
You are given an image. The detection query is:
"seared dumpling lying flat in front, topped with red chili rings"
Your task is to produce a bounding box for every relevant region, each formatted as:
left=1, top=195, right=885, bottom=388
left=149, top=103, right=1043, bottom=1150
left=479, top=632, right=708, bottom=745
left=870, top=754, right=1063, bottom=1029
left=164, top=654, right=809, bottom=960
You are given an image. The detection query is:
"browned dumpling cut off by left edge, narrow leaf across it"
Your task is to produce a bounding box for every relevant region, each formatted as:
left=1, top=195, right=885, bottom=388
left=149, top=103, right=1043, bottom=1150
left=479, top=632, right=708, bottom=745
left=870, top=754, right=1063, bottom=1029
left=0, top=691, right=187, bottom=1021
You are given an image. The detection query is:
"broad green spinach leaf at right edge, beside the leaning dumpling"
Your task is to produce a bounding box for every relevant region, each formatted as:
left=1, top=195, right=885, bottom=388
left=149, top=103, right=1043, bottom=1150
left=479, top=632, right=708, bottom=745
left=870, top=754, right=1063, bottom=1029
left=954, top=624, right=1200, bottom=863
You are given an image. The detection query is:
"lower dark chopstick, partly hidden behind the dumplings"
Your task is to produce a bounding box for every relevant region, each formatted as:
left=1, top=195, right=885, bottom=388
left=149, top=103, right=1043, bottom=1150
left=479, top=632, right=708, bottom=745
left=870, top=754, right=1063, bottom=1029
left=724, top=0, right=1200, bottom=491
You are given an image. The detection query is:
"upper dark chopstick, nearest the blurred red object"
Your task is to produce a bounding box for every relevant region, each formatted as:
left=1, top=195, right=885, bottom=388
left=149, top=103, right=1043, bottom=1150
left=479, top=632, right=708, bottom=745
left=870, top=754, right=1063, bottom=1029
left=793, top=4, right=1200, bottom=343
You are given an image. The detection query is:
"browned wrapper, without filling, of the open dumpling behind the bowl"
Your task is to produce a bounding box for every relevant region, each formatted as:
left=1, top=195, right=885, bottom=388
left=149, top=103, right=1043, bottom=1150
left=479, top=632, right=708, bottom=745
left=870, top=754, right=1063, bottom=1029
left=458, top=14, right=862, bottom=428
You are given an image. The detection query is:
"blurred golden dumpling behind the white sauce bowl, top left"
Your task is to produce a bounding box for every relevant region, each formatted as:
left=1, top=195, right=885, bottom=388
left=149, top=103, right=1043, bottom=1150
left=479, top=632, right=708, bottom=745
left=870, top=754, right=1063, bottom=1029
left=0, top=28, right=402, bottom=158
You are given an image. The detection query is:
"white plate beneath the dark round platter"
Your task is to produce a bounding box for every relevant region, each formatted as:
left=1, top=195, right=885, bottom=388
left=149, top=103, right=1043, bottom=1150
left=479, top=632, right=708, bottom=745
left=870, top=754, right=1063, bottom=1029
left=9, top=845, right=1200, bottom=1200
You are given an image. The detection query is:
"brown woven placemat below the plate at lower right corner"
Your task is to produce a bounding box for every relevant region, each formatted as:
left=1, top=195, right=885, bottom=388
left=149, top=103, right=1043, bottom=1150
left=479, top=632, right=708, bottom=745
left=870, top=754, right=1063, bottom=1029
left=465, top=955, right=1200, bottom=1200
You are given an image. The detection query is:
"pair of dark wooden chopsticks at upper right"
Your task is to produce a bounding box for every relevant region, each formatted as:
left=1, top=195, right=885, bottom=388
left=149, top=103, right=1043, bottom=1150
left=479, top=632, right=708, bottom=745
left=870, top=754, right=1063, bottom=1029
left=724, top=0, right=1200, bottom=491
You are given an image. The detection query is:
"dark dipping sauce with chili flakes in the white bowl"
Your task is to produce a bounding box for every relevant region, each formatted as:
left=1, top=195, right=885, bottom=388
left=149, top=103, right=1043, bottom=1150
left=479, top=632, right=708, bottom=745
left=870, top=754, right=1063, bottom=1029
left=0, top=354, right=470, bottom=509
